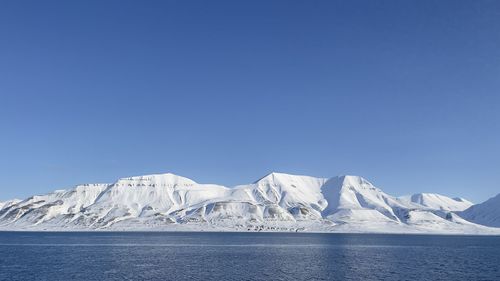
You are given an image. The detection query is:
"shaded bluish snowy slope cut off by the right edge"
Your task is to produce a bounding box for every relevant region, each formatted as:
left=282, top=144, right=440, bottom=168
left=460, top=194, right=500, bottom=227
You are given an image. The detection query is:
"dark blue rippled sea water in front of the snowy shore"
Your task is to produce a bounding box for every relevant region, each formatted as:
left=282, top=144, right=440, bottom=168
left=0, top=232, right=500, bottom=281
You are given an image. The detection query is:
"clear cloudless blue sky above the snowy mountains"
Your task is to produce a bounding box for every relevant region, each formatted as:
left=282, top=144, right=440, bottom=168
left=0, top=0, right=500, bottom=202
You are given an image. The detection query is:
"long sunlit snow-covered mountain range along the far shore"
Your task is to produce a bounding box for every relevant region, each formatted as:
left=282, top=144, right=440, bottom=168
left=0, top=173, right=500, bottom=234
